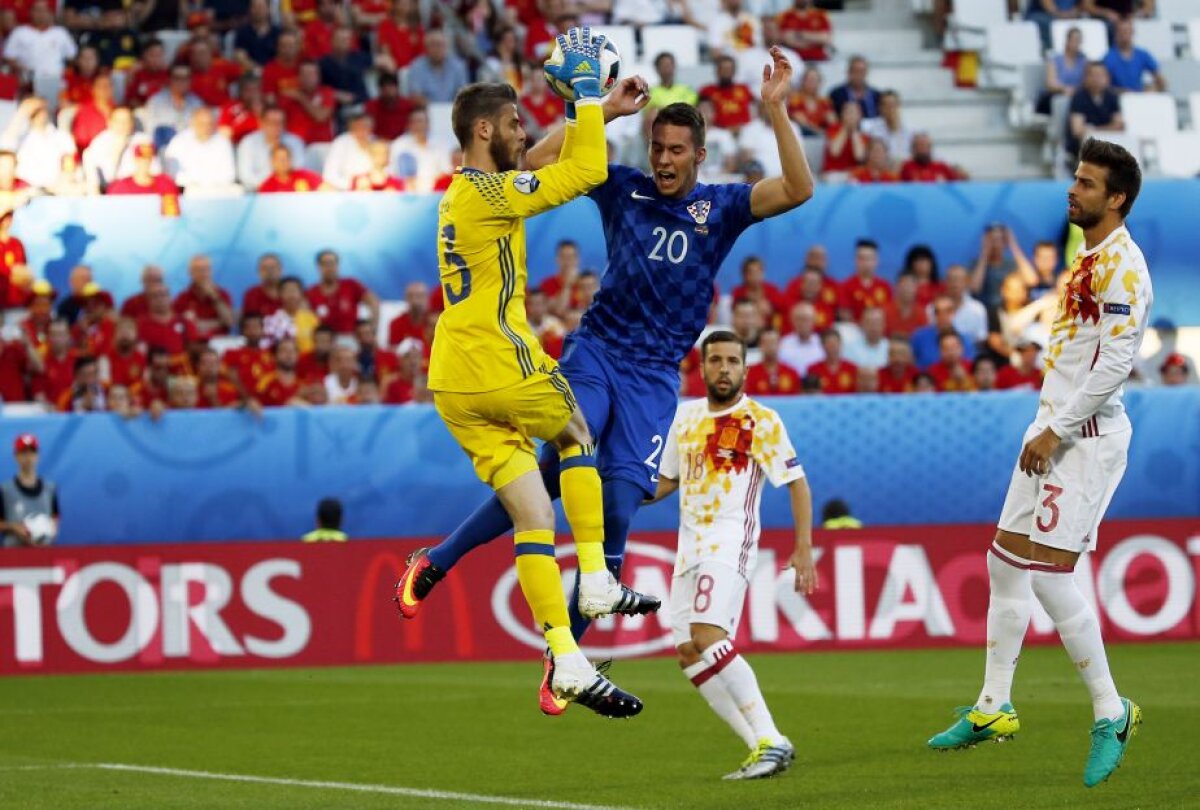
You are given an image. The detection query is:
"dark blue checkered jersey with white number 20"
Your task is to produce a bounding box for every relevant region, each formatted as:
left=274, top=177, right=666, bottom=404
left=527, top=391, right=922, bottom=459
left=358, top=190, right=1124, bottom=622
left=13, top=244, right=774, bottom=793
left=580, top=164, right=756, bottom=366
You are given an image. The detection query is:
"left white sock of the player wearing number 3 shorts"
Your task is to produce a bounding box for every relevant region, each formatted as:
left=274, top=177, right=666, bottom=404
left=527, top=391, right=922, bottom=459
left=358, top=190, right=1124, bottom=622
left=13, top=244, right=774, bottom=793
left=976, top=546, right=1033, bottom=714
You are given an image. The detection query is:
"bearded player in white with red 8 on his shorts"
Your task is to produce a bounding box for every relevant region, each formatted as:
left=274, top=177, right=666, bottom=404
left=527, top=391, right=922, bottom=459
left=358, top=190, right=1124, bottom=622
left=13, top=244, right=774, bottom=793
left=655, top=331, right=817, bottom=779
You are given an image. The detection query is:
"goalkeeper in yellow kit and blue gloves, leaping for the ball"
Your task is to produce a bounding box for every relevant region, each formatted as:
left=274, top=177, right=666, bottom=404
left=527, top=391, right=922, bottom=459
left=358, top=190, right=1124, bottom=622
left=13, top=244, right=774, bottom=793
left=396, top=28, right=642, bottom=718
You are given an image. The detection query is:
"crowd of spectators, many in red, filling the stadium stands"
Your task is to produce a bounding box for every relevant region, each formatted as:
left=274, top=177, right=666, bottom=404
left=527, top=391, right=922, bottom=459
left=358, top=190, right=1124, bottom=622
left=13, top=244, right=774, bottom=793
left=0, top=0, right=1190, bottom=415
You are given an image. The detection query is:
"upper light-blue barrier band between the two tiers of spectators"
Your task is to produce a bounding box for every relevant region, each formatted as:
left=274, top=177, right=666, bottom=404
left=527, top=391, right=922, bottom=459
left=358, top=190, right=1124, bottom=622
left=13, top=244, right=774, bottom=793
left=13, top=180, right=1200, bottom=325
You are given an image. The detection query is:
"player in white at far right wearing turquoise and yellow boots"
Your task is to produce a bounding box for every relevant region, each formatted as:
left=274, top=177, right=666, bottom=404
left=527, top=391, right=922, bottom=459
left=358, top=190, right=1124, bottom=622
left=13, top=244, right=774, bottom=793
left=929, top=139, right=1153, bottom=787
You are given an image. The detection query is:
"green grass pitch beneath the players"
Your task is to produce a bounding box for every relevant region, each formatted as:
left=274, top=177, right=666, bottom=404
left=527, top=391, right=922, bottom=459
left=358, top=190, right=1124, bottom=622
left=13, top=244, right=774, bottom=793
left=0, top=643, right=1200, bottom=810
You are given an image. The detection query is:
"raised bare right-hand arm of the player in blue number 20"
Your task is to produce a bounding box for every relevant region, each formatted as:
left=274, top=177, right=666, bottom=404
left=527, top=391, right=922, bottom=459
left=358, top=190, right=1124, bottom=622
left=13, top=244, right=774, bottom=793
left=750, top=48, right=815, bottom=220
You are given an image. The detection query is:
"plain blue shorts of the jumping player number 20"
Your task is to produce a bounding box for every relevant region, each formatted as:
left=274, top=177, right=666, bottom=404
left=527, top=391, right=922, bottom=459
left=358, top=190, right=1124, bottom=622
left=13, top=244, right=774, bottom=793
left=558, top=335, right=679, bottom=497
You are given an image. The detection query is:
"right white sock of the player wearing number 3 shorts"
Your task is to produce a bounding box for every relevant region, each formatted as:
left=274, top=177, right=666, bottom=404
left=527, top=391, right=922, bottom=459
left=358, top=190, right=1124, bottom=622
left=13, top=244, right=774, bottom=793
left=1033, top=571, right=1124, bottom=720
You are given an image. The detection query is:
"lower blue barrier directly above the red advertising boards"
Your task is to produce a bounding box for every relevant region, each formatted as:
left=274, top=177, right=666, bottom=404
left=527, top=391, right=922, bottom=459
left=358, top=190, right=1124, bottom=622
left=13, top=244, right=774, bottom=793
left=0, top=388, right=1200, bottom=544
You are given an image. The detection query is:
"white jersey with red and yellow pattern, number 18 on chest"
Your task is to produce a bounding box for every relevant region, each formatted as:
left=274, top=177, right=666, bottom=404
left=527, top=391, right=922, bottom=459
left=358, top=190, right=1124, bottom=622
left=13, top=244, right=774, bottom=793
left=659, top=395, right=804, bottom=577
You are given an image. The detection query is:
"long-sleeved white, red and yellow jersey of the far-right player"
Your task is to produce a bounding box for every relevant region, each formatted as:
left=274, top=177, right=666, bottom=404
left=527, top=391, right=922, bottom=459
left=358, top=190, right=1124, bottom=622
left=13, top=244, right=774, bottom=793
left=1034, top=226, right=1154, bottom=438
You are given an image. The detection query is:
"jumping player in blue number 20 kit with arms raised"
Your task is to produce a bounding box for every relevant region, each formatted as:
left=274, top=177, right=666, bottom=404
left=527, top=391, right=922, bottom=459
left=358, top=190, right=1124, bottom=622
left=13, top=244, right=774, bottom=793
left=397, top=48, right=814, bottom=714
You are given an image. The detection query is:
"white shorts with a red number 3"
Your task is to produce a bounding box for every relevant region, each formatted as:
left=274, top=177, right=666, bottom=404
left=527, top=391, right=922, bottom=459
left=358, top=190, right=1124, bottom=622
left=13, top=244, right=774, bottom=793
left=998, top=427, right=1133, bottom=553
